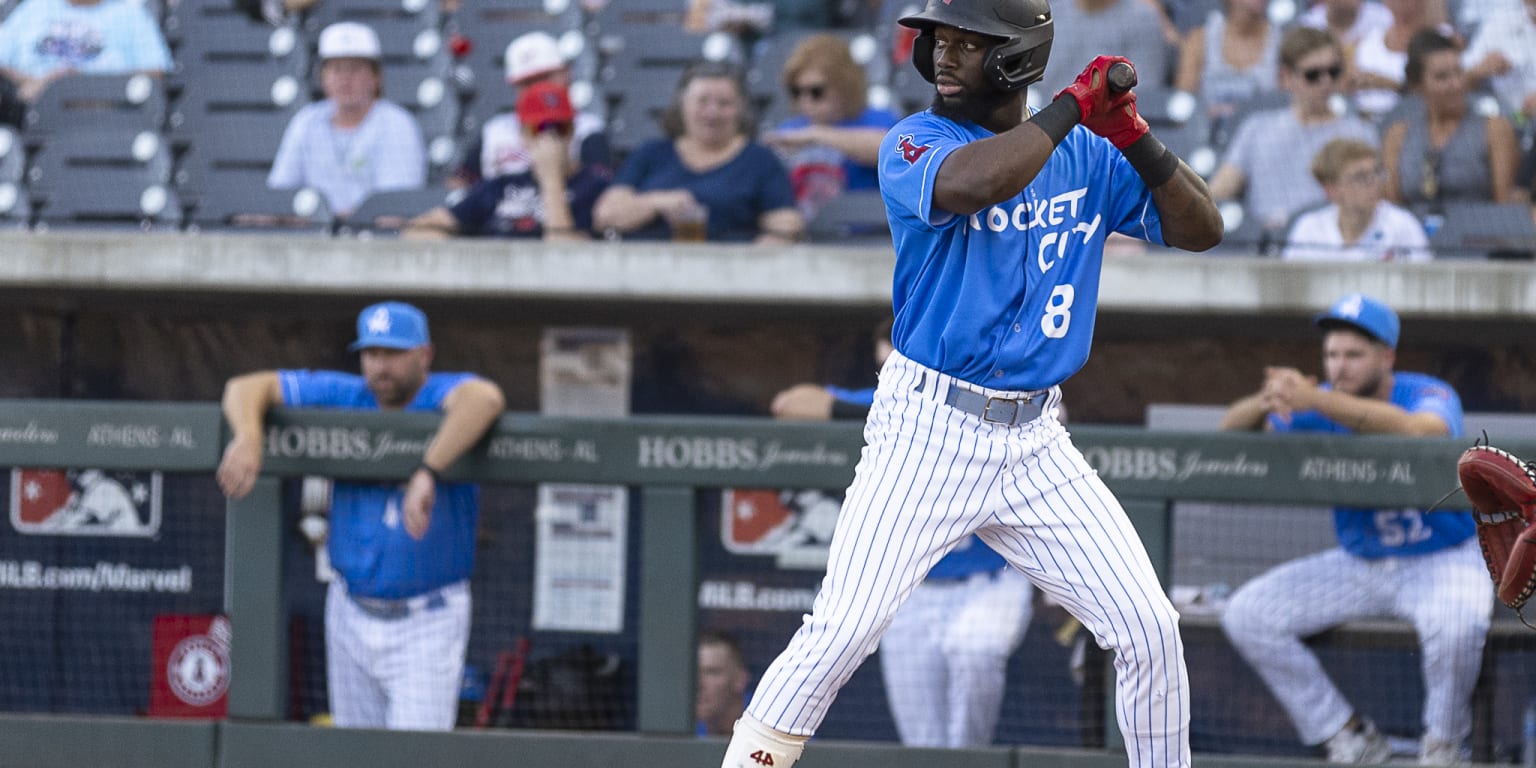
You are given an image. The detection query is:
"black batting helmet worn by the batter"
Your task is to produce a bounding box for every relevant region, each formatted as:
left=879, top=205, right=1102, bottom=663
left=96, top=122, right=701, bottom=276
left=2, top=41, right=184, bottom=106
left=897, top=0, right=1055, bottom=91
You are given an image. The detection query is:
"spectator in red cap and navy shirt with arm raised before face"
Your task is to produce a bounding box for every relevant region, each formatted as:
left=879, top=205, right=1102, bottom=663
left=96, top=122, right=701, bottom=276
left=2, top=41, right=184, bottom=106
left=401, top=81, right=611, bottom=240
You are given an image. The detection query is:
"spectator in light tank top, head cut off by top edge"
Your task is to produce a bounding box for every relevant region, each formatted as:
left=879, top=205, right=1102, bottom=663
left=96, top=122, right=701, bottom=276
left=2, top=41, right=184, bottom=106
left=1174, top=0, right=1279, bottom=121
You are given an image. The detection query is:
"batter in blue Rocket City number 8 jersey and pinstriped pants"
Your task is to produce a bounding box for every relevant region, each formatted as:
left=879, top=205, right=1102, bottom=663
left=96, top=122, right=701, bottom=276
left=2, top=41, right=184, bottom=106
left=722, top=0, right=1221, bottom=768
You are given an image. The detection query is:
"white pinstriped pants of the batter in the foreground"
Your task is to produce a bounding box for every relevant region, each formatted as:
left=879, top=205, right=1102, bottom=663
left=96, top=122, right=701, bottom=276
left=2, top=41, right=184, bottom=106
left=748, top=353, right=1189, bottom=768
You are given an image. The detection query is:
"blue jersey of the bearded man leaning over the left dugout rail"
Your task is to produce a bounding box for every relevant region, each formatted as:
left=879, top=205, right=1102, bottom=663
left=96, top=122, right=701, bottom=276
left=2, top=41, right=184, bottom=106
left=278, top=370, right=479, bottom=599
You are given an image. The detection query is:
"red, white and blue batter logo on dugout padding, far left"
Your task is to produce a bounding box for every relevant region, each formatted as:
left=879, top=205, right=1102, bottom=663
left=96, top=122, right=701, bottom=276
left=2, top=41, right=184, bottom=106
left=11, top=467, right=161, bottom=538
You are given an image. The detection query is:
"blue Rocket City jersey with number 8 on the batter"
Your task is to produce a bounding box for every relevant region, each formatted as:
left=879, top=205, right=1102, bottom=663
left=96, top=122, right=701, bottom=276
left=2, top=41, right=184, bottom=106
left=880, top=112, right=1163, bottom=390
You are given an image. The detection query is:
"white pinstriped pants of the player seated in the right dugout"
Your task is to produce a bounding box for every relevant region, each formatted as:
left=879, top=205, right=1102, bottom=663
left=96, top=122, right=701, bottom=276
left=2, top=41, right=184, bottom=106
left=1221, top=538, right=1493, bottom=745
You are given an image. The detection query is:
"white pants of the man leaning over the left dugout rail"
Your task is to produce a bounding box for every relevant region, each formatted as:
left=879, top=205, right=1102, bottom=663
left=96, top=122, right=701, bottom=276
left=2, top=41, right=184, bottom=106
left=326, top=579, right=470, bottom=731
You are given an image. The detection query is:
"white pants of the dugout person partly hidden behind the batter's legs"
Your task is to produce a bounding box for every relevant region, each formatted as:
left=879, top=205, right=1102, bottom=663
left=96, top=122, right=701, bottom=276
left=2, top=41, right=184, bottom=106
left=880, top=567, right=1034, bottom=748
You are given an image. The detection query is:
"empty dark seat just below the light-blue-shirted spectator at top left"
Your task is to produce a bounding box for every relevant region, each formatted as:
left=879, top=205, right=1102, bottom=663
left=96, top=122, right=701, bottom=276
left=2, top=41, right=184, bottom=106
left=25, top=74, right=166, bottom=146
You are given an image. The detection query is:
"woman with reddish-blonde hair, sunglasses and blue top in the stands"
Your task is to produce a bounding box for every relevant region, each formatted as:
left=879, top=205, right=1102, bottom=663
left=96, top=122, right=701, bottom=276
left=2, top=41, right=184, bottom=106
left=762, top=34, right=899, bottom=220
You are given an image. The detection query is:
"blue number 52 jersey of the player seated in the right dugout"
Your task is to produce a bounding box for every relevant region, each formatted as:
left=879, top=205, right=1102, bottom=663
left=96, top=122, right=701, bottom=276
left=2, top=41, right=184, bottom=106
left=1269, top=373, right=1476, bottom=559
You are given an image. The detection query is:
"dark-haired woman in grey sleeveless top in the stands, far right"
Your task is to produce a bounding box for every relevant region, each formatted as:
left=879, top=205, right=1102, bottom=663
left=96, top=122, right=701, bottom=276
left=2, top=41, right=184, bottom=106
left=1382, top=29, right=1519, bottom=215
